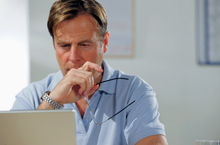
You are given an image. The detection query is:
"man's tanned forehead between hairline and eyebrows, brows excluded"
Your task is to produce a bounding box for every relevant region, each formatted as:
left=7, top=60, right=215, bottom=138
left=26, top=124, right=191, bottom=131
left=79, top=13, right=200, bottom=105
left=55, top=14, right=99, bottom=39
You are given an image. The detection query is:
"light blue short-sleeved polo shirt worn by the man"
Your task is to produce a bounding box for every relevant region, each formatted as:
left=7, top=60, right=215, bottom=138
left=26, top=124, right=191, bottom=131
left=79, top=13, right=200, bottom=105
left=11, top=61, right=165, bottom=145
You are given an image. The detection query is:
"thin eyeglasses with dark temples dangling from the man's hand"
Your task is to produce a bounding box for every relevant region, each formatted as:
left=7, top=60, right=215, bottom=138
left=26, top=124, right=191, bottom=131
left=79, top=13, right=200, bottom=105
left=84, top=78, right=135, bottom=125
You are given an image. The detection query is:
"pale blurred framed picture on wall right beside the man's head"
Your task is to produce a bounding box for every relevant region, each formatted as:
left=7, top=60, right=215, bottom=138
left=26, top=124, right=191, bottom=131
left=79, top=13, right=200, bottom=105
left=97, top=0, right=135, bottom=57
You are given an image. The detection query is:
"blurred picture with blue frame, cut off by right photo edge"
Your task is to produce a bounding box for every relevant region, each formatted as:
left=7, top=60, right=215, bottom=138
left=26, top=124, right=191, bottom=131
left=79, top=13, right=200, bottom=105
left=196, top=0, right=220, bottom=65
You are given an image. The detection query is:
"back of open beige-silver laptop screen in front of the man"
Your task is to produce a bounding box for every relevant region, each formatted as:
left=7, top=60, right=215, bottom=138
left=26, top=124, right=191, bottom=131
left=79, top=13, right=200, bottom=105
left=0, top=110, right=76, bottom=145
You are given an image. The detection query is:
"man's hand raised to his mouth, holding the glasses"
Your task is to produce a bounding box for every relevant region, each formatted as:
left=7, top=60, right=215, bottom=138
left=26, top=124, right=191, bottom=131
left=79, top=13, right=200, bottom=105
left=50, top=62, right=103, bottom=105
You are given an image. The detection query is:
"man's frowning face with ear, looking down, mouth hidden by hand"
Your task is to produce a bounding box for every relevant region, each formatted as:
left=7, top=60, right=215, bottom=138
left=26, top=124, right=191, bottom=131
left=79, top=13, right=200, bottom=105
left=54, top=14, right=109, bottom=76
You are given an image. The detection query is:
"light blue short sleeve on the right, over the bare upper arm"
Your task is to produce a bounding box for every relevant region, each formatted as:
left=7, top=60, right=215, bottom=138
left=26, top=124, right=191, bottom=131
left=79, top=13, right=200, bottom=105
left=124, top=77, right=165, bottom=145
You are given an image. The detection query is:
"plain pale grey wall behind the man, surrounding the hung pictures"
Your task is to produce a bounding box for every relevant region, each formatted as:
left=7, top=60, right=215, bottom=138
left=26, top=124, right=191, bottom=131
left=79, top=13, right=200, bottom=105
left=30, top=0, right=220, bottom=145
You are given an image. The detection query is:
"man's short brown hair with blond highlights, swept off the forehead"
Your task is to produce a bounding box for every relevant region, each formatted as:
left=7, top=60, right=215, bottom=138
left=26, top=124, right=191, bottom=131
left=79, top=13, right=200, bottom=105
left=47, top=0, right=108, bottom=40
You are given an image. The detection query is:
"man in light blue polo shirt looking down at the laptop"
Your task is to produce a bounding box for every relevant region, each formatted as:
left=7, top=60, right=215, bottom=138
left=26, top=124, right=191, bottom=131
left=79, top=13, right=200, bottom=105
left=12, top=0, right=167, bottom=145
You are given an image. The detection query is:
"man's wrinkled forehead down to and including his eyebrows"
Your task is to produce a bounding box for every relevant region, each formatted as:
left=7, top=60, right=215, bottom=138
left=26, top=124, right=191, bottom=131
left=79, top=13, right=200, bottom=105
left=54, top=15, right=102, bottom=44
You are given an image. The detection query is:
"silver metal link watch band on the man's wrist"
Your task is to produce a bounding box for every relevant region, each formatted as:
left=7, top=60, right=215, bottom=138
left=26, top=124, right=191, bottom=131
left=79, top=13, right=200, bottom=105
left=41, top=91, right=63, bottom=109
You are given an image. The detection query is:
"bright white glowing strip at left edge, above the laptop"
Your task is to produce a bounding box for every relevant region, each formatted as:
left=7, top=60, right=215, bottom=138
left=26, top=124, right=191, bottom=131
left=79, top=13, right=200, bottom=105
left=0, top=0, right=30, bottom=110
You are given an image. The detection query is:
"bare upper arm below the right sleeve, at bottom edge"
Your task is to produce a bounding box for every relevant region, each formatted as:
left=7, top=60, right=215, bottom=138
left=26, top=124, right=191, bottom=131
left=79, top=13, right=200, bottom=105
left=135, top=135, right=168, bottom=145
